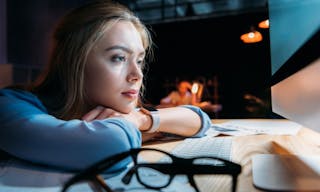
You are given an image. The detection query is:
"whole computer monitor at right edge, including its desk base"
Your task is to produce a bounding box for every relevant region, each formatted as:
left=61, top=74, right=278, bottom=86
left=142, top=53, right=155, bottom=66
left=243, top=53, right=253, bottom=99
left=252, top=0, right=320, bottom=191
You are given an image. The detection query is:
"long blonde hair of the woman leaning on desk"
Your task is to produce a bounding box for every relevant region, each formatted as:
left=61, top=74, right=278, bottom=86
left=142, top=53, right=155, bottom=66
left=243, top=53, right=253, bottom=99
left=33, top=1, right=152, bottom=120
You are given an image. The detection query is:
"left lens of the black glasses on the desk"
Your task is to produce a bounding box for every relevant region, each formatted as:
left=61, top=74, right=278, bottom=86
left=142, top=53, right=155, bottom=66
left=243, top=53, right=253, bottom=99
left=136, top=150, right=172, bottom=188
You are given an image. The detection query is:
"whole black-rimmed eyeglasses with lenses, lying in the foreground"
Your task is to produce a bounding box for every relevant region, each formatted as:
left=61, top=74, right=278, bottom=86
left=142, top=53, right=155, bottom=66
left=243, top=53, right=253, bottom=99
left=61, top=148, right=241, bottom=192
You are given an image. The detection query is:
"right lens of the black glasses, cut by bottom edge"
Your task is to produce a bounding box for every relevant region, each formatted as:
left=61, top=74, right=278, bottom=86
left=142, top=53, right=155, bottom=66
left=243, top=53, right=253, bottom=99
left=193, top=158, right=233, bottom=192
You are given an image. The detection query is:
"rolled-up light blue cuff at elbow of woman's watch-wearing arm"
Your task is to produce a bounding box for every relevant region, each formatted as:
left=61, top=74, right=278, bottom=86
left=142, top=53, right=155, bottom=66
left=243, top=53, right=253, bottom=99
left=181, top=105, right=211, bottom=137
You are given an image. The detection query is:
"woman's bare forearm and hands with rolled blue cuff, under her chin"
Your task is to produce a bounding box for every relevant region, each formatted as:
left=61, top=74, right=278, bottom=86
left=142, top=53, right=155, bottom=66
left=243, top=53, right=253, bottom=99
left=83, top=105, right=211, bottom=137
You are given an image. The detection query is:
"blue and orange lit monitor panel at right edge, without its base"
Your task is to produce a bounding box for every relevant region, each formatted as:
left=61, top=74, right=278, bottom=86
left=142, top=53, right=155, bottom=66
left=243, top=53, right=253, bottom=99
left=268, top=0, right=320, bottom=131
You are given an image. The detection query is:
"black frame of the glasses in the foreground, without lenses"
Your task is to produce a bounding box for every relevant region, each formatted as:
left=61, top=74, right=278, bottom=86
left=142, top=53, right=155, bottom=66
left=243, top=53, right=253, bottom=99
left=61, top=148, right=241, bottom=192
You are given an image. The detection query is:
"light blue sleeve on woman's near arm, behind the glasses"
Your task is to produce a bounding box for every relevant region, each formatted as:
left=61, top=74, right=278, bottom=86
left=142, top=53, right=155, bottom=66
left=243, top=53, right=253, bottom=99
left=0, top=88, right=141, bottom=170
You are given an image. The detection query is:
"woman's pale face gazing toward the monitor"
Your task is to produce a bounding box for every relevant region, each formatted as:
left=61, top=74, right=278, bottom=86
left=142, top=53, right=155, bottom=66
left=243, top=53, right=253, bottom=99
left=85, top=21, right=145, bottom=113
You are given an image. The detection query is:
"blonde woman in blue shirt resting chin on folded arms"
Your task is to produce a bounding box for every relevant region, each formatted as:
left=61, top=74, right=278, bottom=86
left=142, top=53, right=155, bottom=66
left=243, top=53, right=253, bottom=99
left=0, top=1, right=211, bottom=170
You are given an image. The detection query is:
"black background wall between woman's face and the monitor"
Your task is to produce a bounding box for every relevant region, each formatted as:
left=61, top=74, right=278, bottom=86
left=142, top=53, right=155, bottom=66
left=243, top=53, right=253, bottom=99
left=147, top=13, right=271, bottom=118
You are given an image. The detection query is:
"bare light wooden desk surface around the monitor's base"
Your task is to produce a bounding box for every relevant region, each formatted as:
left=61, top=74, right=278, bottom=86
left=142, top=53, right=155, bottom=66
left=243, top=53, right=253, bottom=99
left=143, top=120, right=320, bottom=192
